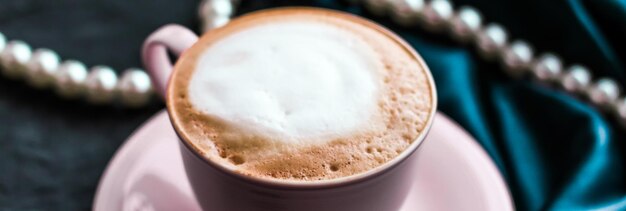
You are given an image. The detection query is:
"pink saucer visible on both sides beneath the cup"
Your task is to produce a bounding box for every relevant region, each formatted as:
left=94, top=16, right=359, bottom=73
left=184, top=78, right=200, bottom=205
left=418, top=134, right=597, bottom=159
left=93, top=111, right=514, bottom=211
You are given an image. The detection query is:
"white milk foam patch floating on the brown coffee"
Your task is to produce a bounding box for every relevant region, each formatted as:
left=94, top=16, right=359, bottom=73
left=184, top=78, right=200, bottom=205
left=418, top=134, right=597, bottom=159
left=188, top=20, right=384, bottom=145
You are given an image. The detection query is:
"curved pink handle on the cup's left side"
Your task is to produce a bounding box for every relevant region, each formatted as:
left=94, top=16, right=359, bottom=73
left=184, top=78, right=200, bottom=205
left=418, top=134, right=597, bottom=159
left=141, top=24, right=198, bottom=98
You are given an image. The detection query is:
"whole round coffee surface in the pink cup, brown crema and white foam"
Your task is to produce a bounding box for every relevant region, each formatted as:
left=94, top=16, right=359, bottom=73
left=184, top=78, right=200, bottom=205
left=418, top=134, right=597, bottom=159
left=167, top=9, right=435, bottom=181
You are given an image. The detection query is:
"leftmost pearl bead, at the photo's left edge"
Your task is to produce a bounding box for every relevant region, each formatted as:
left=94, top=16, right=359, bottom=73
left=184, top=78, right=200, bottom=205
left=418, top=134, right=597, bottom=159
left=0, top=40, right=31, bottom=79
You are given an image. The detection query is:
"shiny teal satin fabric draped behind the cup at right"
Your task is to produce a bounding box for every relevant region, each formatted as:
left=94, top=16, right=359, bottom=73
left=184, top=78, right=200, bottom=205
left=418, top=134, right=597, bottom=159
left=249, top=0, right=626, bottom=210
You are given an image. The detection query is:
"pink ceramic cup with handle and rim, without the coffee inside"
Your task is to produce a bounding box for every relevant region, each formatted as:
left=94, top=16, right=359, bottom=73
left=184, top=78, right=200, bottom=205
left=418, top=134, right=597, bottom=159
left=142, top=8, right=437, bottom=211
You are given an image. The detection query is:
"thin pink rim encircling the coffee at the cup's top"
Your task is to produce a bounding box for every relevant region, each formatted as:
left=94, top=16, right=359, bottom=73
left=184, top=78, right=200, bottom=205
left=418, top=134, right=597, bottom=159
left=166, top=7, right=438, bottom=189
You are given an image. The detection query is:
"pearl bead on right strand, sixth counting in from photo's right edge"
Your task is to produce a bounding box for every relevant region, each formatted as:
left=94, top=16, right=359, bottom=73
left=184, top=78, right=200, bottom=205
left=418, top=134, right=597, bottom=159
left=476, top=23, right=508, bottom=58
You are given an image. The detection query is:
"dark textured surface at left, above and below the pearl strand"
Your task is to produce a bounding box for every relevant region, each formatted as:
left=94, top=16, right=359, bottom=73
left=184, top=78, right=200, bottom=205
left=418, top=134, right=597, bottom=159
left=0, top=0, right=197, bottom=210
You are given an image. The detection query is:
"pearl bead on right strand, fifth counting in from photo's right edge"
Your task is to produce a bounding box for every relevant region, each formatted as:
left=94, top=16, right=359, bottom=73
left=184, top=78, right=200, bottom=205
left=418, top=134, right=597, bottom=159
left=502, top=40, right=533, bottom=74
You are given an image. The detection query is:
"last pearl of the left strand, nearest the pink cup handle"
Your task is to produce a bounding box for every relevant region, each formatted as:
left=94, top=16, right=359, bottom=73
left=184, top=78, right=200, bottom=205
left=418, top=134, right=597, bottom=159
left=117, top=68, right=152, bottom=107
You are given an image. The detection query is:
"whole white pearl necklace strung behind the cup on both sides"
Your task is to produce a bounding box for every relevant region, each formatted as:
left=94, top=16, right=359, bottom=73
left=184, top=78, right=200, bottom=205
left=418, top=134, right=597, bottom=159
left=0, top=0, right=626, bottom=125
